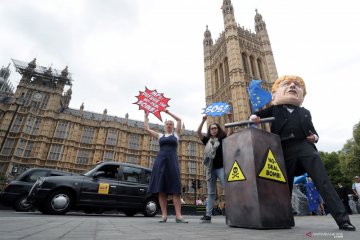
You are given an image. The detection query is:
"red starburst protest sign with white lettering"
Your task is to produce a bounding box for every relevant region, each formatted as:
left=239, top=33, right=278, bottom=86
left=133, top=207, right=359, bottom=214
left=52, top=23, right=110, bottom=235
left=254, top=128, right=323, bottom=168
left=134, top=87, right=170, bottom=121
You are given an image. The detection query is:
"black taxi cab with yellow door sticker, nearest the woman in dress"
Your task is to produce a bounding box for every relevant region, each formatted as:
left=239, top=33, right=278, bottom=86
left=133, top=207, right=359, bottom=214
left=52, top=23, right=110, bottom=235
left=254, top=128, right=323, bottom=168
left=27, top=162, right=159, bottom=217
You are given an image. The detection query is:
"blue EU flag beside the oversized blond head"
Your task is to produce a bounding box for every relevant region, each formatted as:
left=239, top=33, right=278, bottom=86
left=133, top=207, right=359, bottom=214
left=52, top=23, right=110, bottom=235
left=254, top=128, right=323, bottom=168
left=248, top=79, right=271, bottom=112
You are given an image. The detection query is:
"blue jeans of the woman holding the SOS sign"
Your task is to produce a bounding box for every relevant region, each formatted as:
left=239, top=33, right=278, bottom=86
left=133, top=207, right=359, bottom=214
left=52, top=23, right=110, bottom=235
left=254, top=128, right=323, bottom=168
left=206, top=168, right=225, bottom=217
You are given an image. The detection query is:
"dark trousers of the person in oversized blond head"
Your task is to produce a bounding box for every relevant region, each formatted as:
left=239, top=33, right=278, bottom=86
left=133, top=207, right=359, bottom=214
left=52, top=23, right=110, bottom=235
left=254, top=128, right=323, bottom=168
left=282, top=140, right=349, bottom=225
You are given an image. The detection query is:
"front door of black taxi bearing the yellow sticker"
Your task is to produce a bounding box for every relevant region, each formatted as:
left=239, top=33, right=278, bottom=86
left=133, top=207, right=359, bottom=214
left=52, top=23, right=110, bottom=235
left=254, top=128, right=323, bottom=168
left=79, top=164, right=119, bottom=207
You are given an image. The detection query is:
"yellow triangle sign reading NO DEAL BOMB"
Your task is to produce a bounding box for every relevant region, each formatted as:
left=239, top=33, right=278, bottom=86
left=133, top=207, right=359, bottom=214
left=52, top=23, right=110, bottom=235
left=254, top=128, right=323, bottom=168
left=259, top=148, right=286, bottom=183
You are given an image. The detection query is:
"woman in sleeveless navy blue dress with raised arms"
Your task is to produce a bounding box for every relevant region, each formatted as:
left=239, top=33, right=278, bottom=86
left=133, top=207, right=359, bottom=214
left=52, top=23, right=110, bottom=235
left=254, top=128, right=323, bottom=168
left=144, top=110, right=188, bottom=223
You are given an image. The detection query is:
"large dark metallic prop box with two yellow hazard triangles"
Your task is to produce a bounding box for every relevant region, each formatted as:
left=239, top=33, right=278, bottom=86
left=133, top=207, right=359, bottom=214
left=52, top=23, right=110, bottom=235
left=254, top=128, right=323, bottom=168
left=223, top=128, right=295, bottom=229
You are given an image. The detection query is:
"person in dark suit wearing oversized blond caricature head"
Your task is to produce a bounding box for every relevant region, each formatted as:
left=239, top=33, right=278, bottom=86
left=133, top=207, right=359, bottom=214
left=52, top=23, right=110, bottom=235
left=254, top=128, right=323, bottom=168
left=250, top=75, right=356, bottom=231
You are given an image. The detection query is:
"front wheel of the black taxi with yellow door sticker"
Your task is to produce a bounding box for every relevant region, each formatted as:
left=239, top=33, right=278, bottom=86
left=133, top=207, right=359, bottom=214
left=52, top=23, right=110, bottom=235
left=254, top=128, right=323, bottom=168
left=45, top=190, right=74, bottom=214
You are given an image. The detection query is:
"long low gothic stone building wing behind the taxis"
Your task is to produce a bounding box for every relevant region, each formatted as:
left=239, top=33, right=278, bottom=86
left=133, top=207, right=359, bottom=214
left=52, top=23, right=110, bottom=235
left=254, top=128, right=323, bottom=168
left=0, top=59, right=205, bottom=195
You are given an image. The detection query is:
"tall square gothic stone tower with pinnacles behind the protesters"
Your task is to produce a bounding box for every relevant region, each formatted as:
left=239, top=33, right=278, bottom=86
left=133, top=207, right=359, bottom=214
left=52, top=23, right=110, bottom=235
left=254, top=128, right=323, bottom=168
left=203, top=0, right=278, bottom=127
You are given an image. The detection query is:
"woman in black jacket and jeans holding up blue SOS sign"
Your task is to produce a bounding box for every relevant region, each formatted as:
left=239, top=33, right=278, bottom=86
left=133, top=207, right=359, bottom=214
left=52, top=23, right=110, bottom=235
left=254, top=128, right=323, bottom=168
left=197, top=113, right=232, bottom=223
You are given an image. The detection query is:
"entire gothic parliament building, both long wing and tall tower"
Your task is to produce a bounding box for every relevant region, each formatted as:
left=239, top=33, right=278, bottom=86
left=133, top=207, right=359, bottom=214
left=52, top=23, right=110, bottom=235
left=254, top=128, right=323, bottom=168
left=0, top=0, right=277, bottom=201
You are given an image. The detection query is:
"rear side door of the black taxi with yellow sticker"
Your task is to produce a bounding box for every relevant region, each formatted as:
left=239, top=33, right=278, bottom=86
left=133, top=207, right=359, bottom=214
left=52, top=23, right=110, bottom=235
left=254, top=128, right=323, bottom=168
left=119, top=165, right=148, bottom=208
